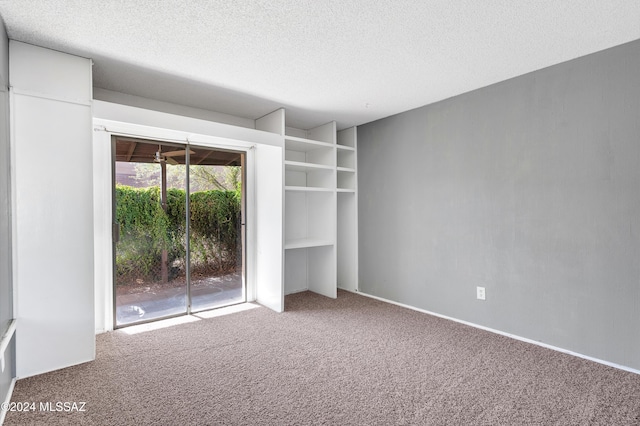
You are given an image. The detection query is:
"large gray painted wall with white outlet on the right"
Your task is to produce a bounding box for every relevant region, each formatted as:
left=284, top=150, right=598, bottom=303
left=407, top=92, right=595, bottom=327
left=358, top=41, right=640, bottom=369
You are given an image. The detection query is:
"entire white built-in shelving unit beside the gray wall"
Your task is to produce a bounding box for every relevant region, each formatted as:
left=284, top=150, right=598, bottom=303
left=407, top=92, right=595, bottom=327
left=256, top=110, right=358, bottom=298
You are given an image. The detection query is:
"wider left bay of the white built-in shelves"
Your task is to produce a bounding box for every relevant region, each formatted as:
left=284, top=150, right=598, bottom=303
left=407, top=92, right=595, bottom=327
left=284, top=122, right=337, bottom=297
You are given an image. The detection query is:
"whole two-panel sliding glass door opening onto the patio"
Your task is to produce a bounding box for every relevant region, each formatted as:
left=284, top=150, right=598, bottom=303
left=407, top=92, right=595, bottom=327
left=112, top=137, right=245, bottom=327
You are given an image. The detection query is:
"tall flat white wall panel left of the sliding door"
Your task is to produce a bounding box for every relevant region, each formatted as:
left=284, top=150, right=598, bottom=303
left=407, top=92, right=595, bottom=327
left=10, top=41, right=95, bottom=378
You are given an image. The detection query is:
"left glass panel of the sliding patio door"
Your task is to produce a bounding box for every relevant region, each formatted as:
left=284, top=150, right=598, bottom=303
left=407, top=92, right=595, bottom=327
left=113, top=138, right=188, bottom=327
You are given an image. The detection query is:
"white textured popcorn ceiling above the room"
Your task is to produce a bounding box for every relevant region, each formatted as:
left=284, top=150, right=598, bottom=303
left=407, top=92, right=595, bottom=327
left=0, top=0, right=640, bottom=128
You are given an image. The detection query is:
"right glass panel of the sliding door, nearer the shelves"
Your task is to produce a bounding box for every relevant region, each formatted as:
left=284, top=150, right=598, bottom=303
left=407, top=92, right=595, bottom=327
left=189, top=146, right=246, bottom=311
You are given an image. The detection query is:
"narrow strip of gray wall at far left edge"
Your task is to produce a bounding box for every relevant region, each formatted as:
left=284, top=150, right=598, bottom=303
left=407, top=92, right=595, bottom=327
left=0, top=14, right=15, bottom=406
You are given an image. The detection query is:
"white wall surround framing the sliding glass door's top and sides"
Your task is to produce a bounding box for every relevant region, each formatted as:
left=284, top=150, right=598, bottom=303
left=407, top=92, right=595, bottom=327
left=93, top=101, right=284, bottom=332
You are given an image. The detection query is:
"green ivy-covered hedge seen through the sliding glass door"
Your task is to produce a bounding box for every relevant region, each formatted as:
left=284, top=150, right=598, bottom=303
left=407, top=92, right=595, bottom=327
left=116, top=185, right=241, bottom=284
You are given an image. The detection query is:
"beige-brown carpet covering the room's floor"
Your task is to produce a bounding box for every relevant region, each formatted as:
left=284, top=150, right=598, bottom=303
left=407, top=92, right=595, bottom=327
left=6, top=292, right=640, bottom=425
